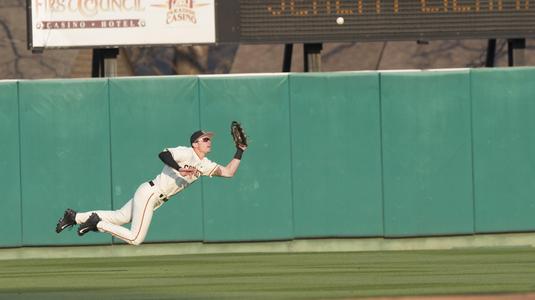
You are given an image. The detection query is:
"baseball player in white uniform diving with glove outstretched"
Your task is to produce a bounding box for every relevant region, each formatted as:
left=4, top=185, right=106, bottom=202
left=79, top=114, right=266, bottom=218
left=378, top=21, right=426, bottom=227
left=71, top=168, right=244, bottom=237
left=56, top=122, right=247, bottom=245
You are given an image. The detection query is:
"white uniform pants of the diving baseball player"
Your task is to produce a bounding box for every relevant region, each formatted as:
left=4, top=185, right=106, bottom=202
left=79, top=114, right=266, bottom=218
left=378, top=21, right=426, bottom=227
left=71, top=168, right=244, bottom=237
left=76, top=183, right=163, bottom=245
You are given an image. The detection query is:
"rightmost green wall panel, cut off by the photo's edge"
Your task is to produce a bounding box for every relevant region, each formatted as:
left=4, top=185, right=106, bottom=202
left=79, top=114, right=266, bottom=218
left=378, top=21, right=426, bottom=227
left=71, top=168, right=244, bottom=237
left=471, top=68, right=535, bottom=232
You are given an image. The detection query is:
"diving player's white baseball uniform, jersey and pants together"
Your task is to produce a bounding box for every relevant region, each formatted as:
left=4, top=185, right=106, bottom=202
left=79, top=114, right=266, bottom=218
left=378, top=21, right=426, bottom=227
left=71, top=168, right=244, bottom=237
left=76, top=146, right=219, bottom=245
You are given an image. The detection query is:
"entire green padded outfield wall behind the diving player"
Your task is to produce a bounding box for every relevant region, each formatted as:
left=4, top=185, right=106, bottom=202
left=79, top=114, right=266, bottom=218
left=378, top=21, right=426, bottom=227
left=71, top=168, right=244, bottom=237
left=0, top=68, right=535, bottom=247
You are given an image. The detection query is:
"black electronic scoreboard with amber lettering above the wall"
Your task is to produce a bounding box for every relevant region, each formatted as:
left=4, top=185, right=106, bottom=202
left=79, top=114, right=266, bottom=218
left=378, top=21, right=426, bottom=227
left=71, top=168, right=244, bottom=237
left=218, top=0, right=535, bottom=43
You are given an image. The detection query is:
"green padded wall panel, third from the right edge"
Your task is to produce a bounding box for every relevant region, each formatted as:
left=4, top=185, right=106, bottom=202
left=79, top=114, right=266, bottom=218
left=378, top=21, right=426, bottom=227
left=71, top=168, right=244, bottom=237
left=290, top=73, right=383, bottom=238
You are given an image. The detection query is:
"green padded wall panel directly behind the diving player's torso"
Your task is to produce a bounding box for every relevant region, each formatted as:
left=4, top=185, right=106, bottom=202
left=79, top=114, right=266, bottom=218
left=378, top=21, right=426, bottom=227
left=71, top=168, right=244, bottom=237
left=109, top=77, right=203, bottom=242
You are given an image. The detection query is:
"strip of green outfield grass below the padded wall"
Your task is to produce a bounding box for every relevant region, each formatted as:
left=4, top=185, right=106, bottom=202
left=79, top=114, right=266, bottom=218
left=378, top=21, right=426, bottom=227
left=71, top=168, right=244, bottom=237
left=0, top=248, right=535, bottom=300
